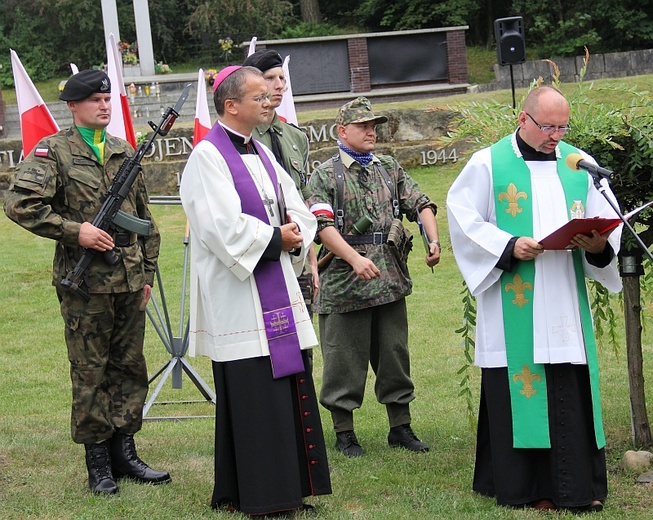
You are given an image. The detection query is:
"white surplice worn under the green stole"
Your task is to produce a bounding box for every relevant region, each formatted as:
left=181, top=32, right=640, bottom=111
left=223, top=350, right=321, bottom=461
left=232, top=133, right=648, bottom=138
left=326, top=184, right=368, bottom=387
left=447, top=135, right=622, bottom=368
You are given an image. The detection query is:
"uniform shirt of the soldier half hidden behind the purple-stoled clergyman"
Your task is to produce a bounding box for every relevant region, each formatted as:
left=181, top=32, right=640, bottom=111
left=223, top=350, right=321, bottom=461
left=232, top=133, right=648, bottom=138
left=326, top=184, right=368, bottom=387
left=252, top=114, right=310, bottom=200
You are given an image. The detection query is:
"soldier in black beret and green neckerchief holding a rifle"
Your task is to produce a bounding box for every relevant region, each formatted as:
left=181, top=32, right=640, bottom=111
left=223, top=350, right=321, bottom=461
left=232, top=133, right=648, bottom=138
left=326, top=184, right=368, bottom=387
left=4, top=70, right=170, bottom=494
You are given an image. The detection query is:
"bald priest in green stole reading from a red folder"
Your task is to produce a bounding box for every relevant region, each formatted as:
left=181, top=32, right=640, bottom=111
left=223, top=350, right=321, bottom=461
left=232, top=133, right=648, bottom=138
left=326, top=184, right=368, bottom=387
left=447, top=87, right=621, bottom=510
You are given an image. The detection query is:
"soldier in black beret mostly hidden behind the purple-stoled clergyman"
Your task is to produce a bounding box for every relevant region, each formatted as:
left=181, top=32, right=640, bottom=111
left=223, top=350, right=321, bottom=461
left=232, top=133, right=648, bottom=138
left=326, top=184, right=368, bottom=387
left=243, top=49, right=320, bottom=362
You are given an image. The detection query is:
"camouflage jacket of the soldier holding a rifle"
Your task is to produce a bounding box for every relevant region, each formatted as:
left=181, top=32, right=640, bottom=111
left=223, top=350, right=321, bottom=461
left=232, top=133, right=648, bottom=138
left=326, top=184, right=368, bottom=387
left=4, top=126, right=160, bottom=293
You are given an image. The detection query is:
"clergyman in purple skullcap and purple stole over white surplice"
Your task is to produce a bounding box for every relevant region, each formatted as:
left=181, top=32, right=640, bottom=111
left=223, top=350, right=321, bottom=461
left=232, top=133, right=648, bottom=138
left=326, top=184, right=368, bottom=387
left=180, top=66, right=331, bottom=515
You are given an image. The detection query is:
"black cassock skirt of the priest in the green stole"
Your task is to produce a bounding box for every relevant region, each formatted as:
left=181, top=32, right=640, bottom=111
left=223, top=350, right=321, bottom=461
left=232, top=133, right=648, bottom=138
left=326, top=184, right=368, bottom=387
left=473, top=363, right=608, bottom=507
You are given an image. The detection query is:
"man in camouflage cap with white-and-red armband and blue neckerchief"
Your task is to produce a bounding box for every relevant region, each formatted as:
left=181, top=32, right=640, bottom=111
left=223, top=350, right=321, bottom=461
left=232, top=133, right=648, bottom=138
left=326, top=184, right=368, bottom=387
left=308, top=97, right=440, bottom=457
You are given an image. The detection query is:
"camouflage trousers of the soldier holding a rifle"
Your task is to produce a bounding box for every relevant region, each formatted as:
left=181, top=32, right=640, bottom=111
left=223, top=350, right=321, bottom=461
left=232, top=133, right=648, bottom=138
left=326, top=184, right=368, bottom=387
left=57, top=289, right=148, bottom=444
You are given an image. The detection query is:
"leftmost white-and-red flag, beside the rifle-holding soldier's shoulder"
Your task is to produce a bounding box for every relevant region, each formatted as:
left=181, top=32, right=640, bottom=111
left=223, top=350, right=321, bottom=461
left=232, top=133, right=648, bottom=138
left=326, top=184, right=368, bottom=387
left=9, top=49, right=59, bottom=156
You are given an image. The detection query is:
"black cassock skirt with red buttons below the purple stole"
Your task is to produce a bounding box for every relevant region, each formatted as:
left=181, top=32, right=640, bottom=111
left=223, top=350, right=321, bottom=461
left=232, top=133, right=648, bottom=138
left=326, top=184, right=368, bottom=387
left=211, top=351, right=331, bottom=515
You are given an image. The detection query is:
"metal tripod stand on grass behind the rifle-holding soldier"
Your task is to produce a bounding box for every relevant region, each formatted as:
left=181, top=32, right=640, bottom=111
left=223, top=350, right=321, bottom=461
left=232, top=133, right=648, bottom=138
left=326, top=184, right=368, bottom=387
left=143, top=196, right=216, bottom=420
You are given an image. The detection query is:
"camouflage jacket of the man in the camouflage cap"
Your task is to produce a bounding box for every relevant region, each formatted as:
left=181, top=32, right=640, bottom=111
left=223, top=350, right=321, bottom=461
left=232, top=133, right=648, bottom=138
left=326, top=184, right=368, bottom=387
left=308, top=148, right=437, bottom=314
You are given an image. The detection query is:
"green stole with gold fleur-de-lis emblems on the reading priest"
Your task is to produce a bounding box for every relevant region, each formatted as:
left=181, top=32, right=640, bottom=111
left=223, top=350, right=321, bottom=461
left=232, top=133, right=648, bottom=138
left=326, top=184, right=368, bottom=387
left=491, top=134, right=605, bottom=449
